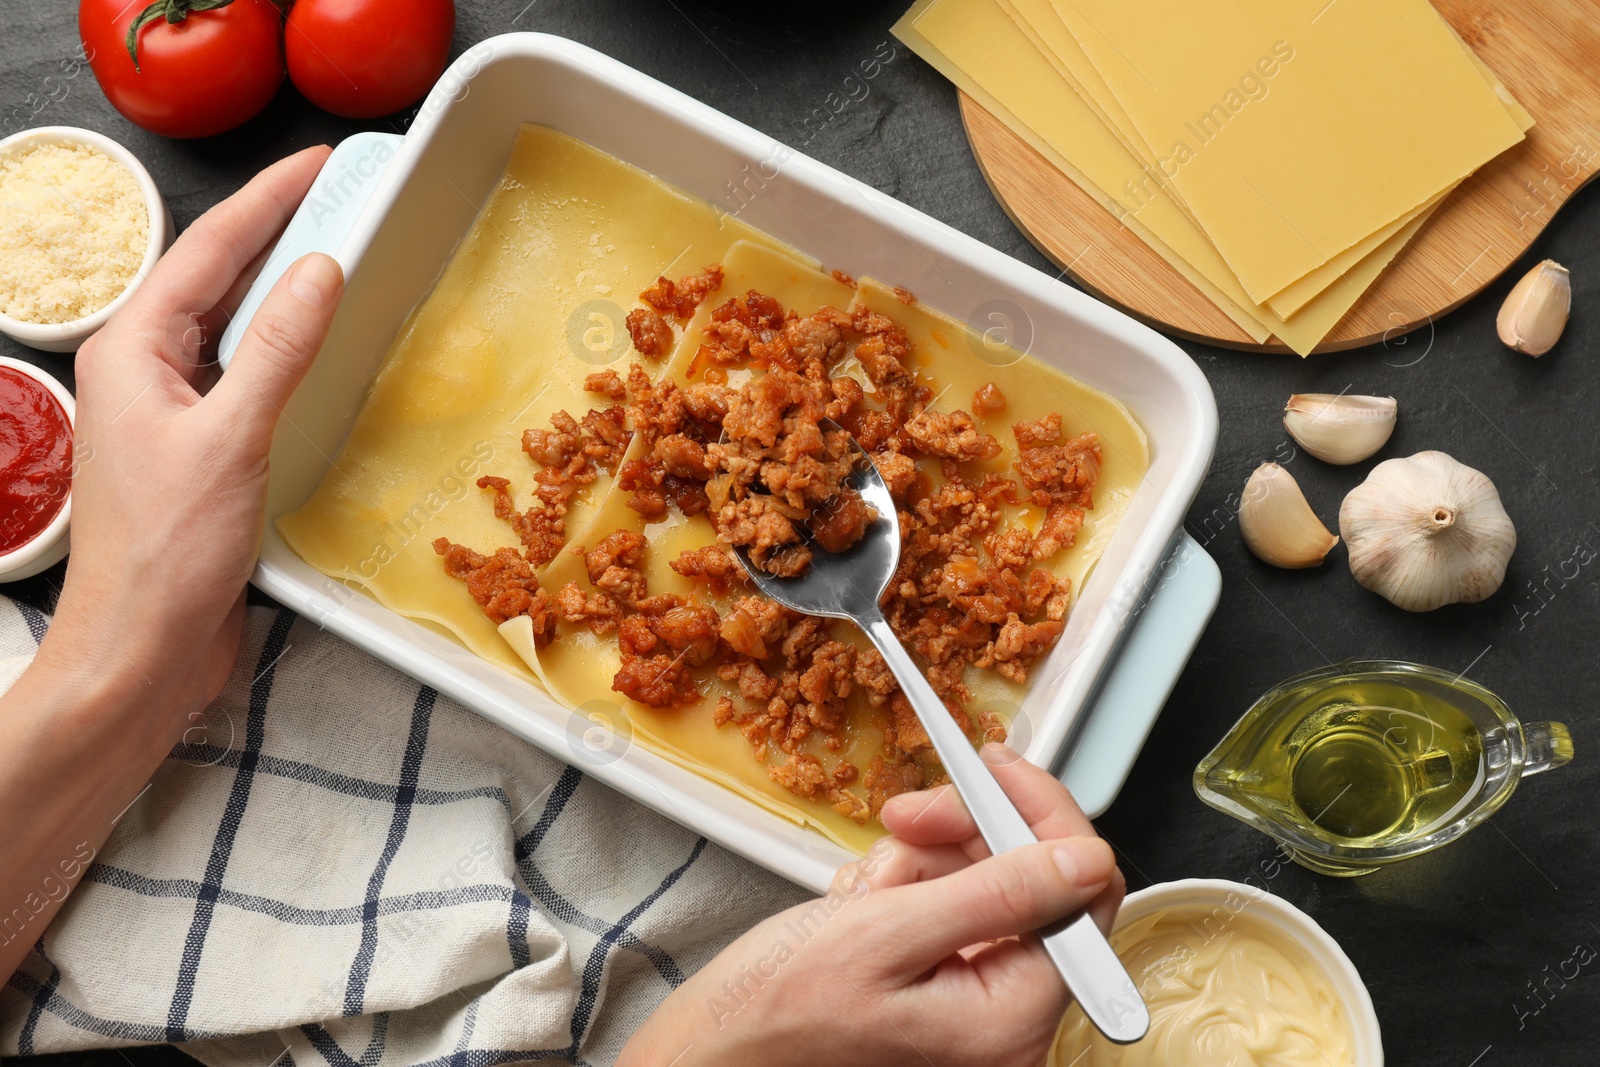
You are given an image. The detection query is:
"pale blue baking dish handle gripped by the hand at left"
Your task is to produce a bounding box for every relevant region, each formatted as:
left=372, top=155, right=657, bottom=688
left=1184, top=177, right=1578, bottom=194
left=218, top=133, right=403, bottom=370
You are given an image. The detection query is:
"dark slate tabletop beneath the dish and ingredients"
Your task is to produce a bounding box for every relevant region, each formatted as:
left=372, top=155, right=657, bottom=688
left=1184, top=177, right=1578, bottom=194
left=0, top=0, right=1600, bottom=1067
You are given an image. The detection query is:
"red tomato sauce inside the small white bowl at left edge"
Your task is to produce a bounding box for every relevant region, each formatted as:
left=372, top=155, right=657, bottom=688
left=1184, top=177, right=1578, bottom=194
left=0, top=366, right=72, bottom=553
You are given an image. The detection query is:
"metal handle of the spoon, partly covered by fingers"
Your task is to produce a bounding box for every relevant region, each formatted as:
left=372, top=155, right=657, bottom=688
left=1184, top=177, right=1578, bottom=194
left=861, top=613, right=1150, bottom=1043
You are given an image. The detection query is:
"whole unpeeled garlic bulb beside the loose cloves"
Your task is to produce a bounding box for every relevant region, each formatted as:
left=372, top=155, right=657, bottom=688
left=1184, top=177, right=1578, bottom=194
left=1339, top=453, right=1517, bottom=611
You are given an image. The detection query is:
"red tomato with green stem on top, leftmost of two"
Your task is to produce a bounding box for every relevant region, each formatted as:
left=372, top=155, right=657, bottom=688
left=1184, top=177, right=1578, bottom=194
left=78, top=0, right=283, bottom=138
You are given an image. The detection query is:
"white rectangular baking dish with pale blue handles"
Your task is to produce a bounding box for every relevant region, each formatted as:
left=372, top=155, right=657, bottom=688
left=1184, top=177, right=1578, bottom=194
left=222, top=34, right=1218, bottom=889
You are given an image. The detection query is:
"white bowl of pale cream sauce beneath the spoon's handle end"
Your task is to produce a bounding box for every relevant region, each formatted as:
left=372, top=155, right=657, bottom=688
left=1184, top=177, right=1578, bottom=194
left=1050, top=878, right=1384, bottom=1067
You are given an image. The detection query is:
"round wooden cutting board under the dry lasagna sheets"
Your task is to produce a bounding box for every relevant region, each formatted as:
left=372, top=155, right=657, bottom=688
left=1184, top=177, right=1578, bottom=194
left=960, top=0, right=1600, bottom=352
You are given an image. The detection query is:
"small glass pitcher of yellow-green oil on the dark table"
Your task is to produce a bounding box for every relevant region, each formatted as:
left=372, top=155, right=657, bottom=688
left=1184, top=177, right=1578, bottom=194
left=1194, top=661, right=1573, bottom=877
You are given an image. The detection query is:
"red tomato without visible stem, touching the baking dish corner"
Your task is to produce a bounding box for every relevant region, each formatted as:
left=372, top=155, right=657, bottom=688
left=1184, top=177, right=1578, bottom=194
left=283, top=0, right=456, bottom=118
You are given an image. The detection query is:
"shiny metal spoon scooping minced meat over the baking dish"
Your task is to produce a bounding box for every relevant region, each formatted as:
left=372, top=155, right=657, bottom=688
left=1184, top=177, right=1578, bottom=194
left=734, top=419, right=1150, bottom=1043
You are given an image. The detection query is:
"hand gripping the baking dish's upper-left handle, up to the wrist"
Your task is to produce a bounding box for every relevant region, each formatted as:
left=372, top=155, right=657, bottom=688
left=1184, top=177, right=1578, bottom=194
left=50, top=149, right=342, bottom=729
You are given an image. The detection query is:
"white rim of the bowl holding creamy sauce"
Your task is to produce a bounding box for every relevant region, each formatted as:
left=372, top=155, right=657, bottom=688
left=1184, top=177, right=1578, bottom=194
left=1117, top=878, right=1384, bottom=1067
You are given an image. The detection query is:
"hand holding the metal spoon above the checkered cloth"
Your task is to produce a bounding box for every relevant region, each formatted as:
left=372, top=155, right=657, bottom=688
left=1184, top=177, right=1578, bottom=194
left=619, top=745, right=1123, bottom=1067
